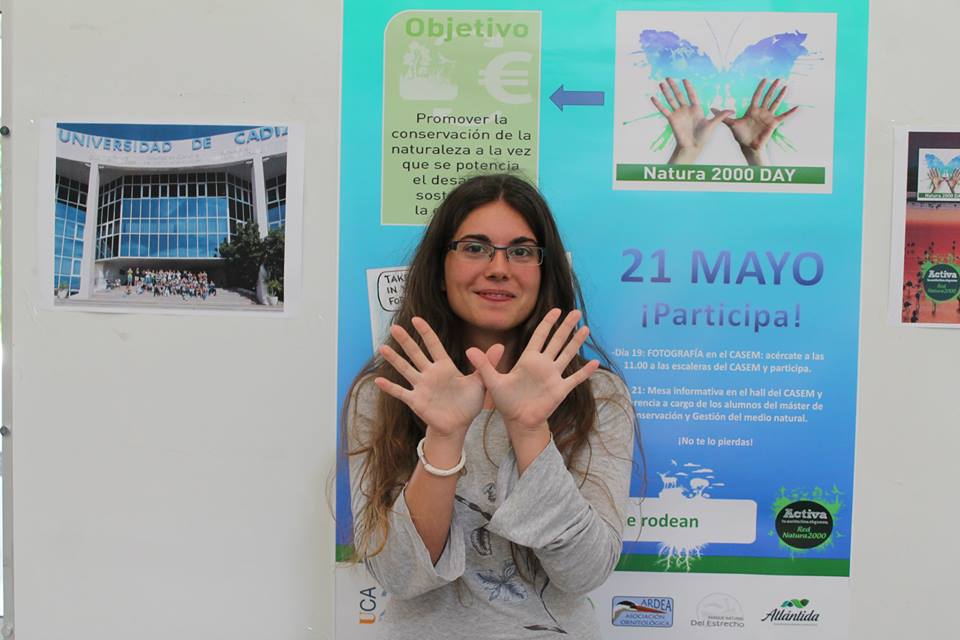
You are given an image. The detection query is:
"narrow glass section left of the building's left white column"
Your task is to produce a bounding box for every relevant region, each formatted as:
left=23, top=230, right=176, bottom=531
left=53, top=176, right=87, bottom=294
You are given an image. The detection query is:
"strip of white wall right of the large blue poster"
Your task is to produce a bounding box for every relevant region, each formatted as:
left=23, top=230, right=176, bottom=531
left=851, top=0, right=960, bottom=639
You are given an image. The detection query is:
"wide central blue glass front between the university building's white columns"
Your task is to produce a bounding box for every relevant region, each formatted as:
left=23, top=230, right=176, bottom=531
left=96, top=171, right=254, bottom=260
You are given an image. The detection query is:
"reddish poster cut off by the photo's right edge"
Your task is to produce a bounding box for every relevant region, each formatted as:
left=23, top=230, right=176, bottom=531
left=890, top=127, right=960, bottom=328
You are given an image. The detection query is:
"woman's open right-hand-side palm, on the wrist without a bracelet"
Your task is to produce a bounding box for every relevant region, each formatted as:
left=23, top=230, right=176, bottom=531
left=467, top=309, right=600, bottom=434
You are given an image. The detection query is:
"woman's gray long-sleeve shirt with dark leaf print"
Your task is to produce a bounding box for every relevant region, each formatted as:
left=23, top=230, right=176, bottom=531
left=348, top=371, right=634, bottom=640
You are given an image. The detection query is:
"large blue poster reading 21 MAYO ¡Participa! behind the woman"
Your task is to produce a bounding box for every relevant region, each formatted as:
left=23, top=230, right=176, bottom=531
left=337, top=0, right=872, bottom=638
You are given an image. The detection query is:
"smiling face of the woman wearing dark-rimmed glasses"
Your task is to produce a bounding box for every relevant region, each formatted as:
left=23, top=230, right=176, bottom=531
left=443, top=200, right=540, bottom=349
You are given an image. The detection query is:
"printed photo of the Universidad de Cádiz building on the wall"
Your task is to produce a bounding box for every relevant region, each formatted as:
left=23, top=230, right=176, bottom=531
left=37, top=121, right=303, bottom=317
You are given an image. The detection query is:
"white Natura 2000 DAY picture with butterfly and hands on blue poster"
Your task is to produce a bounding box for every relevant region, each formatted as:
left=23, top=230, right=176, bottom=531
left=613, top=11, right=837, bottom=193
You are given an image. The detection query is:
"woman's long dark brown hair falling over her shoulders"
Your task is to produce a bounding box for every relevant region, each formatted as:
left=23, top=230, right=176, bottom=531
left=340, top=174, right=639, bottom=572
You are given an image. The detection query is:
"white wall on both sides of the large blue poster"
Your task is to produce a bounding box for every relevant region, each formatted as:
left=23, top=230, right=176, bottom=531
left=0, top=0, right=960, bottom=640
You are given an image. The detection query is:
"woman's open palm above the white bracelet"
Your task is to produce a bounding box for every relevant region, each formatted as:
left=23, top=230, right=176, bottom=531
left=374, top=318, right=503, bottom=437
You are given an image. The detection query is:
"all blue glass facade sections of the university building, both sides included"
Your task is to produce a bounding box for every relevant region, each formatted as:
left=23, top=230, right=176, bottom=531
left=53, top=160, right=287, bottom=295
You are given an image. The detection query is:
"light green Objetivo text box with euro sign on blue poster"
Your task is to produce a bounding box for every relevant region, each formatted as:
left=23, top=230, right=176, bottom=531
left=380, top=11, right=540, bottom=225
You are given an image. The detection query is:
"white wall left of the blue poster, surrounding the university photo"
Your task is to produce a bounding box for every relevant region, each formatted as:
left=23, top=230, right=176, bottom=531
left=2, top=0, right=340, bottom=640
